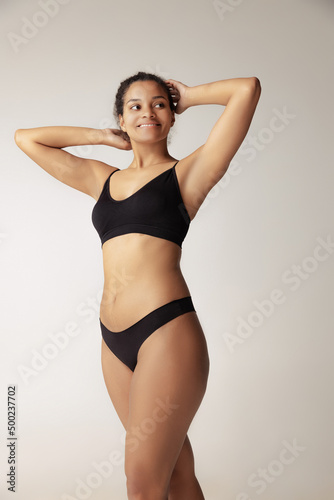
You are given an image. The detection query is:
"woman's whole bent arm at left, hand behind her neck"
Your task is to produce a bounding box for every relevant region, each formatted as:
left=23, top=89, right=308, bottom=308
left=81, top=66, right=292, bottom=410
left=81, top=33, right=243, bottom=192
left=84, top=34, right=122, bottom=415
left=15, top=126, right=131, bottom=199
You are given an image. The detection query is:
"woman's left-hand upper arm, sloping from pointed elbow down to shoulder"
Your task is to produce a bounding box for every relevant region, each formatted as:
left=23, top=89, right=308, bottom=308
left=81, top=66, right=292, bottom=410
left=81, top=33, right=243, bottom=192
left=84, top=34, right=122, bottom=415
left=15, top=130, right=113, bottom=200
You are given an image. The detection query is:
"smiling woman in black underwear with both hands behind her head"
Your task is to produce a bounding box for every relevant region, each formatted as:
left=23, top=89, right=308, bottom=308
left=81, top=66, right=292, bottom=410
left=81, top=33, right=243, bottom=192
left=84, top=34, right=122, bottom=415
left=15, top=72, right=261, bottom=500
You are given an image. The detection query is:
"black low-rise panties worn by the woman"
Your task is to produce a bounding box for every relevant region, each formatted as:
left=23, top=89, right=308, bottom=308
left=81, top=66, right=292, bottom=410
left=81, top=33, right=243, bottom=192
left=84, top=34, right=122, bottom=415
left=100, top=296, right=195, bottom=371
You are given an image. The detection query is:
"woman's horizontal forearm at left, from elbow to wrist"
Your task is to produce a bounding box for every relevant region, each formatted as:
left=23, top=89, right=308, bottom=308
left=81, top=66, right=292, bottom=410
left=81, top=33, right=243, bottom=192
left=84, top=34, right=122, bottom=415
left=15, top=126, right=104, bottom=148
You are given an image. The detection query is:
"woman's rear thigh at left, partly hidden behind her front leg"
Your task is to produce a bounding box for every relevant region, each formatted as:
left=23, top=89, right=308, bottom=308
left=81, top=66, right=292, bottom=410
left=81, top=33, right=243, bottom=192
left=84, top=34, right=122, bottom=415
left=101, top=339, right=133, bottom=429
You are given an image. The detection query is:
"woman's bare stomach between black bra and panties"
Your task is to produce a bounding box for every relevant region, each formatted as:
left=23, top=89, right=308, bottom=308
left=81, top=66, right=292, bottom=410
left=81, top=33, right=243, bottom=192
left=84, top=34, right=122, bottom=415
left=100, top=233, right=190, bottom=332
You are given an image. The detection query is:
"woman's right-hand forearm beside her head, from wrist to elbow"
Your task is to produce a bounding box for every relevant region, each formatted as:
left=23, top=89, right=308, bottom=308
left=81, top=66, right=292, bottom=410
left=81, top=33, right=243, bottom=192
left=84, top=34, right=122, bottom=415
left=186, top=77, right=260, bottom=107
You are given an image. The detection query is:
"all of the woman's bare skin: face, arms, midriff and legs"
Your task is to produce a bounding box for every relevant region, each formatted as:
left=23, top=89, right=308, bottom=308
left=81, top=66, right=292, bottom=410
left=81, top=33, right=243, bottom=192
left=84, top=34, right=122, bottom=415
left=15, top=78, right=261, bottom=500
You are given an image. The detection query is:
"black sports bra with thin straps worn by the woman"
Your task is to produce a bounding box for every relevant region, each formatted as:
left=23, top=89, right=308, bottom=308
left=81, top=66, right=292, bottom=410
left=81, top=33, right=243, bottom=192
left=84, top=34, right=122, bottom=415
left=92, top=162, right=190, bottom=247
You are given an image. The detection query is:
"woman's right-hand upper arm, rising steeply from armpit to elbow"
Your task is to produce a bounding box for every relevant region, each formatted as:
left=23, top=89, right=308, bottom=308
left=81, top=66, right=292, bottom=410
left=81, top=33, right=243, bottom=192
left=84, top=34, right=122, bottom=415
left=180, top=78, right=261, bottom=211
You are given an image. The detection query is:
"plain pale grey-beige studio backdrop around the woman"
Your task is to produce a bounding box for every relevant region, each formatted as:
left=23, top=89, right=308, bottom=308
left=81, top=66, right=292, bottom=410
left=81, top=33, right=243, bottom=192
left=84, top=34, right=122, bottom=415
left=0, top=0, right=334, bottom=500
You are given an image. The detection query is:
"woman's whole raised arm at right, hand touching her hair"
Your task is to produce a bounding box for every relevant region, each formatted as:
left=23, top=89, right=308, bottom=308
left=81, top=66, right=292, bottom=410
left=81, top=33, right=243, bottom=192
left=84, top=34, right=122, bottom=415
left=166, top=77, right=261, bottom=212
